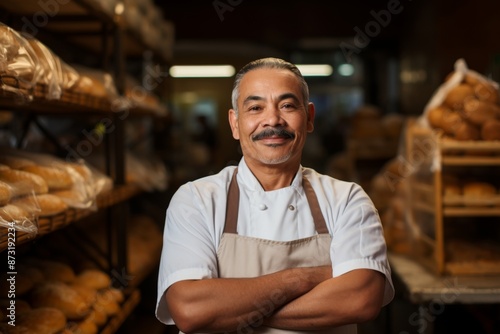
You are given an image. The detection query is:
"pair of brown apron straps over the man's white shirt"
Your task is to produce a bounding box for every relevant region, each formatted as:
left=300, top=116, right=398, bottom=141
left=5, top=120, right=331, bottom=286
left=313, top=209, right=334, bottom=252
left=224, top=168, right=329, bottom=234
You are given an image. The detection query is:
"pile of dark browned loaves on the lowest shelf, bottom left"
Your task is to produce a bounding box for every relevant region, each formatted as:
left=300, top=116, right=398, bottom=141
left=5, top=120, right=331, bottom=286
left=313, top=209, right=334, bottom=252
left=0, top=253, right=140, bottom=334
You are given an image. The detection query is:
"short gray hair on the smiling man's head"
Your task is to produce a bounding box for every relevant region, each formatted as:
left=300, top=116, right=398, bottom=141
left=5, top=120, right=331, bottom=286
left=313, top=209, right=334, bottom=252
left=231, top=57, right=309, bottom=115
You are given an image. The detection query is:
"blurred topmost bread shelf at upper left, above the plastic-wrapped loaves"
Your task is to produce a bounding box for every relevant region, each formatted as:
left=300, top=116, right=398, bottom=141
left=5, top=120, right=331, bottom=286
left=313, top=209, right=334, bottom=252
left=0, top=0, right=175, bottom=61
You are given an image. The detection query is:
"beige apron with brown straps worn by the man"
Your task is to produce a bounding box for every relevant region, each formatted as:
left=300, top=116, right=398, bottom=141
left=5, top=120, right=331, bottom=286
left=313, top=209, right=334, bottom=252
left=217, top=170, right=357, bottom=334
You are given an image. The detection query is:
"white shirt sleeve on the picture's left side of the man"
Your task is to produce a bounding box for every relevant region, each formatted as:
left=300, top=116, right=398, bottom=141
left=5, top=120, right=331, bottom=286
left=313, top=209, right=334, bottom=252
left=156, top=183, right=217, bottom=324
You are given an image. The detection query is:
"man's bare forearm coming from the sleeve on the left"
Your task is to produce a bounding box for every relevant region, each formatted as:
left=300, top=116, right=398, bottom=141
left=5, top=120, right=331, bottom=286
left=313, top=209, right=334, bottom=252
left=166, top=267, right=331, bottom=333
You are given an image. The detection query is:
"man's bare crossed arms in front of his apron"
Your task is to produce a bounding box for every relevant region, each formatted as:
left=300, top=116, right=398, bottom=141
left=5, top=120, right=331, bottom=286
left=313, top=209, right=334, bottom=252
left=166, top=266, right=385, bottom=333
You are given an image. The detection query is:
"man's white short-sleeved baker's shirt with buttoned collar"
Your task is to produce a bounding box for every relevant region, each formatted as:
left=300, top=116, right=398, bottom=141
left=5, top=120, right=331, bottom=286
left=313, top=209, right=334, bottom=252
left=156, top=158, right=394, bottom=324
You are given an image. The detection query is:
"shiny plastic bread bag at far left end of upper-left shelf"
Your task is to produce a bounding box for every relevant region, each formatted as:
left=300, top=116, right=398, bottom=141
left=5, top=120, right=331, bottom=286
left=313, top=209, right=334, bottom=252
left=0, top=23, right=41, bottom=99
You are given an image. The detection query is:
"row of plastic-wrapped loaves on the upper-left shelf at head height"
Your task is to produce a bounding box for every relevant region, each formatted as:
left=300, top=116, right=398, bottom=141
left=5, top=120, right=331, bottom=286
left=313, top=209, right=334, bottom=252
left=0, top=18, right=166, bottom=116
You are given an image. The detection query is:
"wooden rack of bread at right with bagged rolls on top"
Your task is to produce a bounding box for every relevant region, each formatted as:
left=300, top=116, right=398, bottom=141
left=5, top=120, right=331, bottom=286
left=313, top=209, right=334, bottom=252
left=404, top=60, right=500, bottom=275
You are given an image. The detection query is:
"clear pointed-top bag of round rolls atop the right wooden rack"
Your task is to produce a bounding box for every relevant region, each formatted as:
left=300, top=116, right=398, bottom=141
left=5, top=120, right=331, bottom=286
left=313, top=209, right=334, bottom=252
left=419, top=59, right=500, bottom=141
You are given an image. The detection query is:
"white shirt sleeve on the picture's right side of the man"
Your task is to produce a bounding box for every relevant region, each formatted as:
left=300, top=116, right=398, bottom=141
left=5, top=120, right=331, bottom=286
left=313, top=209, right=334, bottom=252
left=330, top=184, right=394, bottom=305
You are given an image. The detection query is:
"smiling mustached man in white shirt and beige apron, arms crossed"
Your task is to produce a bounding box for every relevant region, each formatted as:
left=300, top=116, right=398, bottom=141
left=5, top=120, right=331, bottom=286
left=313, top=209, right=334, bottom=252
left=156, top=58, right=394, bottom=333
